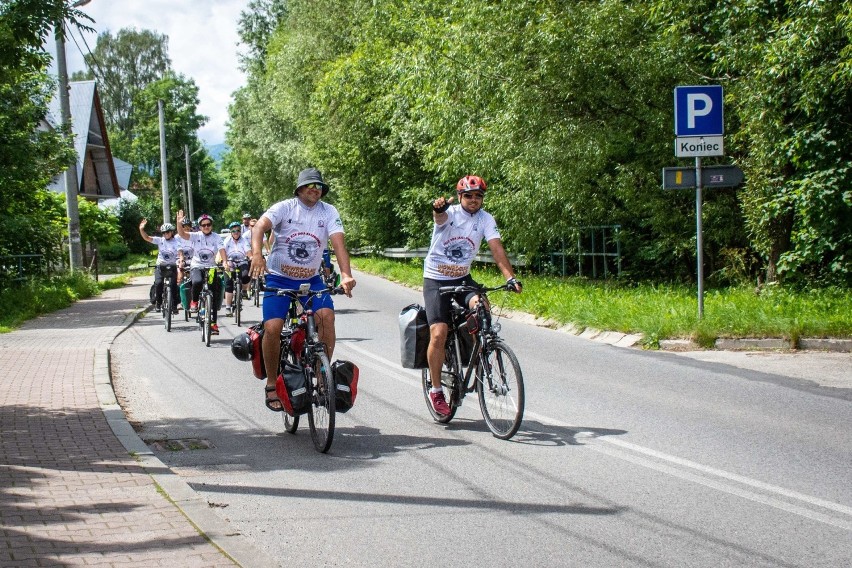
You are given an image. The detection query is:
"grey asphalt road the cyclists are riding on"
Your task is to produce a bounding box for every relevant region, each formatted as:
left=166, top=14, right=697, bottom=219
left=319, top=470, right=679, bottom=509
left=111, top=274, right=852, bottom=568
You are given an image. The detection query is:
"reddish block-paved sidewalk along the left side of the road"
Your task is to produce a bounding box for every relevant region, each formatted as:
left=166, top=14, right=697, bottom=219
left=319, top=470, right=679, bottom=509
left=0, top=280, right=240, bottom=567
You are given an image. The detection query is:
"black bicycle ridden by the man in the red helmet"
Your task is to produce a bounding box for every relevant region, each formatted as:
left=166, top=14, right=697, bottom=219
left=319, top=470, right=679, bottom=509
left=422, top=284, right=524, bottom=440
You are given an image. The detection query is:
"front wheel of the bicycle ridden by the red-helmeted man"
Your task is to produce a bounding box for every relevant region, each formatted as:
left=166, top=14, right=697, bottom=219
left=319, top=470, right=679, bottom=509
left=476, top=341, right=524, bottom=440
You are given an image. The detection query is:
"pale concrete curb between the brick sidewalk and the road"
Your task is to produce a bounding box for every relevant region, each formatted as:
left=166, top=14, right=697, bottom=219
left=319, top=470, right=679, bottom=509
left=94, top=307, right=278, bottom=568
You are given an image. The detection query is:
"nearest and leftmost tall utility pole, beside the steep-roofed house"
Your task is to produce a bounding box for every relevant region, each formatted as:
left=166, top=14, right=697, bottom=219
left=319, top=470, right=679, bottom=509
left=55, top=22, right=83, bottom=272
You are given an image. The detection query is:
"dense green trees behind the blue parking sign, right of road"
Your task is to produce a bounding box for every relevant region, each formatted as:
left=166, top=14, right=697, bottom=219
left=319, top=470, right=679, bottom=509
left=225, top=0, right=852, bottom=284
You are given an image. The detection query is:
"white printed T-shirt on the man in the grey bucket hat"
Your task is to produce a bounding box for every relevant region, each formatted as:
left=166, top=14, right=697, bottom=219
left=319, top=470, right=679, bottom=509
left=264, top=197, right=343, bottom=280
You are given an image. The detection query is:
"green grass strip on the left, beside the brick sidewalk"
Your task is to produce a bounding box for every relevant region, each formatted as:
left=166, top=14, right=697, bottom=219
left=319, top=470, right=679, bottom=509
left=0, top=273, right=130, bottom=333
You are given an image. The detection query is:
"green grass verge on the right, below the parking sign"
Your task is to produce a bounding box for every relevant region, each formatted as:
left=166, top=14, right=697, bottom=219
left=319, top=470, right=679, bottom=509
left=352, top=257, right=852, bottom=347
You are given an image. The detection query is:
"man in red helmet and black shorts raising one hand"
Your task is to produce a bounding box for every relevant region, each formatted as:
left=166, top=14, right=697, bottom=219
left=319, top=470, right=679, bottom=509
left=423, top=175, right=521, bottom=415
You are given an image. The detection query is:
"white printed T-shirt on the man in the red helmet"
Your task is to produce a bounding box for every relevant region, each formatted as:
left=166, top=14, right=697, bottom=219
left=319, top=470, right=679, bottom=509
left=423, top=204, right=500, bottom=280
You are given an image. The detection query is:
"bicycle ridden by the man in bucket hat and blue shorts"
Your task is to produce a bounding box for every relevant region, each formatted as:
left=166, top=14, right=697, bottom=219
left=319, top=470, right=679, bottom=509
left=265, top=283, right=344, bottom=453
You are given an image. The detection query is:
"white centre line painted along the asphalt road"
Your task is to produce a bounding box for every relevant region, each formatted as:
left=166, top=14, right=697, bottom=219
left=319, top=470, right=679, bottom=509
left=338, top=342, right=852, bottom=531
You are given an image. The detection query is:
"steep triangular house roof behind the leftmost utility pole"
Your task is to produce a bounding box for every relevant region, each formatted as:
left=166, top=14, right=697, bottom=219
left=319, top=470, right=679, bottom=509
left=48, top=81, right=120, bottom=199
